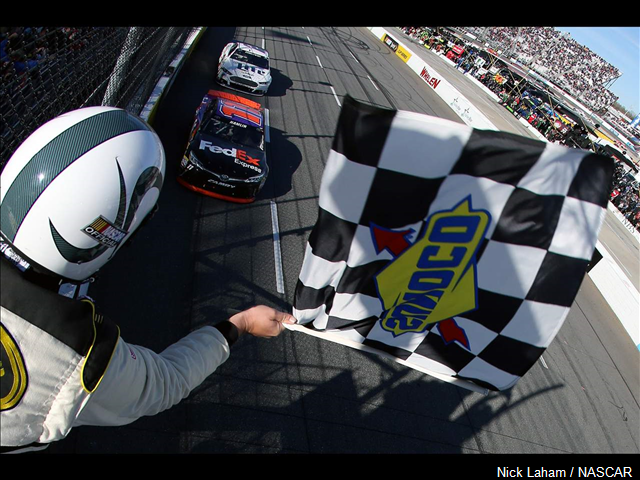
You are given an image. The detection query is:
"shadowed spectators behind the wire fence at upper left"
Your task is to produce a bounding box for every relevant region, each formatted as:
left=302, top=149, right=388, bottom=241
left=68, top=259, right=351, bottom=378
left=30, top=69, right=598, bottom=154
left=0, top=26, right=131, bottom=167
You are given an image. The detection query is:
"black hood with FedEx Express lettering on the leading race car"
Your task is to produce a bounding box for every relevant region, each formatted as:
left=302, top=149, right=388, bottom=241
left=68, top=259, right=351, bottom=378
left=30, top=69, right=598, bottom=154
left=189, top=134, right=268, bottom=180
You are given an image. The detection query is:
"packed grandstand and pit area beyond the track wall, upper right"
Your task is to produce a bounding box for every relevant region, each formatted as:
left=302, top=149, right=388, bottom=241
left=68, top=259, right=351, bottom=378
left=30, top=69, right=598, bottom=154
left=401, top=27, right=640, bottom=231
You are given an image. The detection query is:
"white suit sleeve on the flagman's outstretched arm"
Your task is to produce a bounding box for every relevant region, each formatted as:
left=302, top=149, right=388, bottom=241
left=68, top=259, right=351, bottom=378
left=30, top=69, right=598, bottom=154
left=74, top=327, right=229, bottom=427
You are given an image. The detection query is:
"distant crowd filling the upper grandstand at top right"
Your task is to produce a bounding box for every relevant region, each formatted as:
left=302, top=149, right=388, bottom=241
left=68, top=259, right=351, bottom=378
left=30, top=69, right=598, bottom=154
left=462, top=27, right=621, bottom=111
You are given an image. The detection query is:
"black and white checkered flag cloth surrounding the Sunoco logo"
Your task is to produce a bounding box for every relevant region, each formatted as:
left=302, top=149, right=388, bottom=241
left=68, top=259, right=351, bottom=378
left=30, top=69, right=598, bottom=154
left=293, top=97, right=613, bottom=390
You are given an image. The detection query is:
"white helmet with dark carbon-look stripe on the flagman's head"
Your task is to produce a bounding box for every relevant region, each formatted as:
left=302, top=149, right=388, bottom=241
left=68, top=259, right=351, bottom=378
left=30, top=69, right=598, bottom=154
left=0, top=107, right=165, bottom=281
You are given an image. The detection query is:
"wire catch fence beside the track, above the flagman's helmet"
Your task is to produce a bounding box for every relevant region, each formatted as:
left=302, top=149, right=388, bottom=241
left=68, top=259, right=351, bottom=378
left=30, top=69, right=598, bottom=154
left=0, top=27, right=195, bottom=171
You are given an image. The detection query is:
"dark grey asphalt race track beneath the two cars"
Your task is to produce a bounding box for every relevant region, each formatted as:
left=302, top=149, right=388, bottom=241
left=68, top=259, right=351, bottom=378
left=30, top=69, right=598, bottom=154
left=46, top=27, right=640, bottom=458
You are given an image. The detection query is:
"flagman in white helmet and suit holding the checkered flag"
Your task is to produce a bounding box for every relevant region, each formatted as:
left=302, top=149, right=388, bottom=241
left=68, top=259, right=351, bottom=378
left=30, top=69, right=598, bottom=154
left=0, top=107, right=295, bottom=452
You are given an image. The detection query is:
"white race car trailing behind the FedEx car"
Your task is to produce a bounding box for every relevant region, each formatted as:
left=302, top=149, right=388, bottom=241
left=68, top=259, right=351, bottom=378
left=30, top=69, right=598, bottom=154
left=217, top=42, right=271, bottom=95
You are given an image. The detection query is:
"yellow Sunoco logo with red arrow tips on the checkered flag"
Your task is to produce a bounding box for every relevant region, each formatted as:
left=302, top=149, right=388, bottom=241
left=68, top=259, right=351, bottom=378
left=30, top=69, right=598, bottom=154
left=371, top=197, right=491, bottom=348
